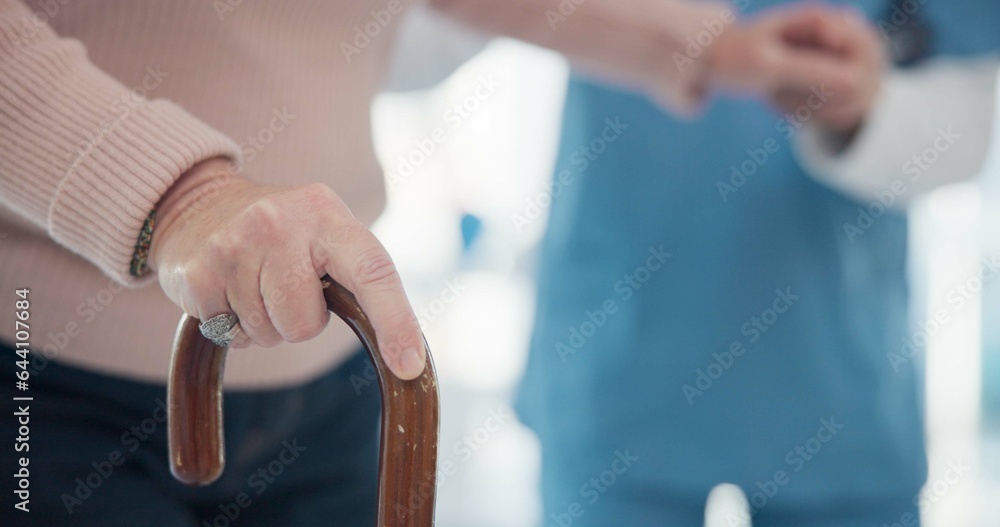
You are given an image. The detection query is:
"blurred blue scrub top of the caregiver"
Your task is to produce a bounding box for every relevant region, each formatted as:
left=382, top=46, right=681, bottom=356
left=518, top=0, right=1000, bottom=525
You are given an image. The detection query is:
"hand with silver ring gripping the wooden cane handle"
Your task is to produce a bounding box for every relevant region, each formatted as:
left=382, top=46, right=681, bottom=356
left=149, top=160, right=426, bottom=379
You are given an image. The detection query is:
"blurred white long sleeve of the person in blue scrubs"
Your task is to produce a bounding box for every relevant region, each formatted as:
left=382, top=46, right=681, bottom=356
left=795, top=56, right=1000, bottom=207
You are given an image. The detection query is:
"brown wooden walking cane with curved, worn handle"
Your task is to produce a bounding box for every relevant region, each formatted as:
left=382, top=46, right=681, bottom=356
left=167, top=276, right=439, bottom=527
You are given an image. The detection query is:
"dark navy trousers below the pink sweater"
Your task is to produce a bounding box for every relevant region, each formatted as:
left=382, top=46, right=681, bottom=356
left=0, top=345, right=380, bottom=527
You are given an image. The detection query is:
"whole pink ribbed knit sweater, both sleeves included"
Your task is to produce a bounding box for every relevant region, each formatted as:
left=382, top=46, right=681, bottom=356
left=0, top=0, right=720, bottom=387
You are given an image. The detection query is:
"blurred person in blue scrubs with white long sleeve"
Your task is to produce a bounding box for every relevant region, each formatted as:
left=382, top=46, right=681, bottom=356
left=439, top=0, right=1000, bottom=527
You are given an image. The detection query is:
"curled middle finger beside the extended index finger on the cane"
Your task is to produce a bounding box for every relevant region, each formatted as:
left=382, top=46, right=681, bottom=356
left=260, top=256, right=330, bottom=342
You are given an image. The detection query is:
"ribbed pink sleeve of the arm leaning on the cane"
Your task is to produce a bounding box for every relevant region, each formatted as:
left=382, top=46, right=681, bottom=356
left=0, top=0, right=240, bottom=286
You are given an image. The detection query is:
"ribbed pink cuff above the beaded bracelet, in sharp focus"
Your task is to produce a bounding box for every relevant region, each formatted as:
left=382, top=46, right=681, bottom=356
left=49, top=101, right=239, bottom=285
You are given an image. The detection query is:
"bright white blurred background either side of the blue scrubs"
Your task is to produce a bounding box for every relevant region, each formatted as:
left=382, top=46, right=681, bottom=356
left=373, top=6, right=1000, bottom=527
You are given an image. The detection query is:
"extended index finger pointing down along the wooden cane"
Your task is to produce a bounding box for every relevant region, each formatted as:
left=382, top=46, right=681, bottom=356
left=313, top=225, right=427, bottom=379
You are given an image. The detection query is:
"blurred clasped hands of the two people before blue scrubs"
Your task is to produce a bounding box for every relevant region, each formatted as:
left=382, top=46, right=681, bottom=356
left=709, top=5, right=886, bottom=133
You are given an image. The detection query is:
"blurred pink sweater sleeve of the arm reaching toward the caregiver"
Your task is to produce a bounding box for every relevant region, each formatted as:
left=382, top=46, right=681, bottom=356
left=431, top=0, right=737, bottom=113
